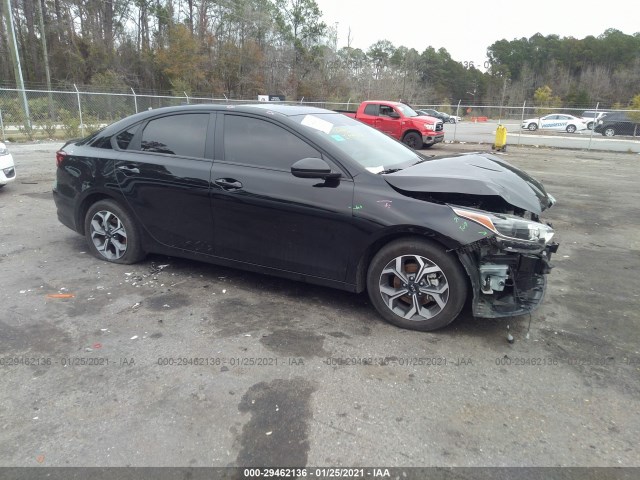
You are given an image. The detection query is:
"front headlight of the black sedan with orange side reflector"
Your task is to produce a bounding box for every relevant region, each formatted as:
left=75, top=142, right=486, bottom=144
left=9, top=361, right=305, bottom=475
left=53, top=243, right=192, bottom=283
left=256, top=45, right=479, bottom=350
left=452, top=207, right=554, bottom=244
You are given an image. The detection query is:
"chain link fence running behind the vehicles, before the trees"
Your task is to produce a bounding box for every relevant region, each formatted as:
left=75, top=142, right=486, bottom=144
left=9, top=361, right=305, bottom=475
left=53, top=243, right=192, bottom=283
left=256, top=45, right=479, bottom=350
left=0, top=85, right=640, bottom=151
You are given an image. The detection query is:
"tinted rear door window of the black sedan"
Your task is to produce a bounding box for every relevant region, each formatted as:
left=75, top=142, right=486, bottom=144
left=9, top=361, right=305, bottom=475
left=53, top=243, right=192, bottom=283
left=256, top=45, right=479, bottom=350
left=138, top=113, right=209, bottom=158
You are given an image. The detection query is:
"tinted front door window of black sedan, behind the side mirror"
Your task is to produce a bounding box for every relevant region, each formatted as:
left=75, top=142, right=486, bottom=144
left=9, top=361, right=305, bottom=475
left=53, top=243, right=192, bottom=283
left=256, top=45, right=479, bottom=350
left=224, top=115, right=322, bottom=171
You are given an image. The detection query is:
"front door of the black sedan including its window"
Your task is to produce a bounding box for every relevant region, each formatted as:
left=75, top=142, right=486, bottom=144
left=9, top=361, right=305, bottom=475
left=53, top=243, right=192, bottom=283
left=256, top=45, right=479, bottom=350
left=212, top=112, right=354, bottom=281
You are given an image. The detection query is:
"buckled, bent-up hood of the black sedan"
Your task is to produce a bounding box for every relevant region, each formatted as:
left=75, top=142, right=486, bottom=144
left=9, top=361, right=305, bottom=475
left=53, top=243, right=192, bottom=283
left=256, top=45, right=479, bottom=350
left=383, top=153, right=555, bottom=215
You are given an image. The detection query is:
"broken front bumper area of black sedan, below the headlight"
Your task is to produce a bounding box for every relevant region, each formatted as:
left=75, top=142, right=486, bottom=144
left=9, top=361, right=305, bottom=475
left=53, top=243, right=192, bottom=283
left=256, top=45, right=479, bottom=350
left=457, top=238, right=558, bottom=318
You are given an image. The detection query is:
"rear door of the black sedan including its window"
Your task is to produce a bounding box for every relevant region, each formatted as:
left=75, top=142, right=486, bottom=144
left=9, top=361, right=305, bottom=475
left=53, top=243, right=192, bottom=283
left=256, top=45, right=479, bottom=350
left=115, top=111, right=216, bottom=254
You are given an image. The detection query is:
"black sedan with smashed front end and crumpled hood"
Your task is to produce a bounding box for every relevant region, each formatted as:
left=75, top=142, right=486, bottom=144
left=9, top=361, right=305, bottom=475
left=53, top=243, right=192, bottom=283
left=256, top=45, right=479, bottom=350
left=53, top=104, right=557, bottom=330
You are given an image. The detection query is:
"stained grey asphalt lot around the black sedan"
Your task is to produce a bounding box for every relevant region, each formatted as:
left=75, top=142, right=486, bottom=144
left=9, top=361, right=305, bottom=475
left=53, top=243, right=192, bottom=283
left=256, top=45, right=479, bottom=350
left=0, top=140, right=640, bottom=466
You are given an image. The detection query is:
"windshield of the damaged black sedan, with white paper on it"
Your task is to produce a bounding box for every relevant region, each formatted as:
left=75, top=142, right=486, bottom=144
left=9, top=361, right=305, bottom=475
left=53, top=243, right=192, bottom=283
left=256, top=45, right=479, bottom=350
left=291, top=113, right=421, bottom=173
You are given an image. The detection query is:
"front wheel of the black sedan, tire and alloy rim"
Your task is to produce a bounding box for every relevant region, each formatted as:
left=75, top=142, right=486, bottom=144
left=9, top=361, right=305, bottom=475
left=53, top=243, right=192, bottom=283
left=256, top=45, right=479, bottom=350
left=367, top=237, right=468, bottom=331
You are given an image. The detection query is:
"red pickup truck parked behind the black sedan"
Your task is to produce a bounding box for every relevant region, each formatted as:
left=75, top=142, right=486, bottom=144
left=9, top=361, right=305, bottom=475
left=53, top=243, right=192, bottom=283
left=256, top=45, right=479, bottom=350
left=336, top=100, right=444, bottom=150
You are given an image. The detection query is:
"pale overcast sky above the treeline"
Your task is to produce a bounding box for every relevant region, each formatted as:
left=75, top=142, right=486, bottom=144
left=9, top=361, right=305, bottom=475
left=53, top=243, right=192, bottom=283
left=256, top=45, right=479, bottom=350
left=316, top=0, right=640, bottom=66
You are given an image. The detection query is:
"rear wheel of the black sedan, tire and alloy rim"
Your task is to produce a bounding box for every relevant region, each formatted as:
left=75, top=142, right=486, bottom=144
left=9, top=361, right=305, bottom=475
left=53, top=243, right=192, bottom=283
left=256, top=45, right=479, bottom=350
left=84, top=200, right=145, bottom=264
